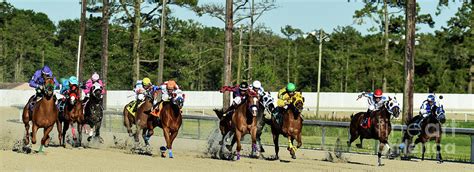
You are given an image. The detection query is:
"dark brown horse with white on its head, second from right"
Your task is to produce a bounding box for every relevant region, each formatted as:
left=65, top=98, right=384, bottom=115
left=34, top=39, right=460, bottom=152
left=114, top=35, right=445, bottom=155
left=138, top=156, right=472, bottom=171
left=347, top=97, right=400, bottom=166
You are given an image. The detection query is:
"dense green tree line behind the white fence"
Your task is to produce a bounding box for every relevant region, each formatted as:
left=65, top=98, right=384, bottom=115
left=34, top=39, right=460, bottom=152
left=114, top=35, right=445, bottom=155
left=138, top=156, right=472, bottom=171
left=0, top=0, right=474, bottom=93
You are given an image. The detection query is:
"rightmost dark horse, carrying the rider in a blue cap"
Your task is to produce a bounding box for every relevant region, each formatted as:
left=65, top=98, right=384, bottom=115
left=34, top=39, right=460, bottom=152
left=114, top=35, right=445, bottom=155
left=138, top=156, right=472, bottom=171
left=402, top=105, right=446, bottom=163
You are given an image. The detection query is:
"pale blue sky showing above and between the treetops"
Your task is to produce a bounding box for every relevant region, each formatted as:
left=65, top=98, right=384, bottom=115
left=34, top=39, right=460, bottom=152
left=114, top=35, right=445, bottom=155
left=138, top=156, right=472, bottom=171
left=7, top=0, right=462, bottom=33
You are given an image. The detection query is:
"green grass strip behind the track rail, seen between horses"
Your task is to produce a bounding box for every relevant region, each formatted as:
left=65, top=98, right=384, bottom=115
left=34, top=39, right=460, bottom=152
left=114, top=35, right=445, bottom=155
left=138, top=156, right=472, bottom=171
left=99, top=116, right=474, bottom=161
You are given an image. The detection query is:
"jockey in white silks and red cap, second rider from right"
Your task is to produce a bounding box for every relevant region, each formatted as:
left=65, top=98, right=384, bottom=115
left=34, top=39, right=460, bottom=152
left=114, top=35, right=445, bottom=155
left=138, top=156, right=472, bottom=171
left=357, top=89, right=387, bottom=127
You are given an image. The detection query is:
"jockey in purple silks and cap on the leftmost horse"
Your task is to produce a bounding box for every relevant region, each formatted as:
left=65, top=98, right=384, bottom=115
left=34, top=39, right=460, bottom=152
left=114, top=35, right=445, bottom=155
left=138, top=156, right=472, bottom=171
left=29, top=66, right=59, bottom=102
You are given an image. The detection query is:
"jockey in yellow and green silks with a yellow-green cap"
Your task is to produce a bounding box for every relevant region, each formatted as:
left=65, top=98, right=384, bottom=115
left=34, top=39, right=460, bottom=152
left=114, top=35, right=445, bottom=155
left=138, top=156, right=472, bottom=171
left=273, top=82, right=302, bottom=124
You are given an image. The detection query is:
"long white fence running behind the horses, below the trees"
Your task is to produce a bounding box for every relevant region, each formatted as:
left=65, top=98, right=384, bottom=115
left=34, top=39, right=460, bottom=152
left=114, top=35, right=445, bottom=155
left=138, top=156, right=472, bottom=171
left=0, top=90, right=474, bottom=114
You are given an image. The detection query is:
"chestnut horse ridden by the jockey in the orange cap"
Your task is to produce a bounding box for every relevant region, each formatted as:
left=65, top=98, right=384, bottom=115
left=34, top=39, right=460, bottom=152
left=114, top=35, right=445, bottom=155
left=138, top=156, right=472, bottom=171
left=145, top=97, right=184, bottom=158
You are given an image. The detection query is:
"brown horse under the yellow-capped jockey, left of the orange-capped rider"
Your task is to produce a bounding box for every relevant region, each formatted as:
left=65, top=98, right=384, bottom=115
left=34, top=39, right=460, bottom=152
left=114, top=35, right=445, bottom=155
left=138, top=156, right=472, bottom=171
left=123, top=94, right=156, bottom=145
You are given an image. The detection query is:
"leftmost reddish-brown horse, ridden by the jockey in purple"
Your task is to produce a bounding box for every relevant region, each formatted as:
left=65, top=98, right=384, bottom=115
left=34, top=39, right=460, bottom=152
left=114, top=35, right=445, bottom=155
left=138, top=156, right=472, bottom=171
left=22, top=77, right=58, bottom=152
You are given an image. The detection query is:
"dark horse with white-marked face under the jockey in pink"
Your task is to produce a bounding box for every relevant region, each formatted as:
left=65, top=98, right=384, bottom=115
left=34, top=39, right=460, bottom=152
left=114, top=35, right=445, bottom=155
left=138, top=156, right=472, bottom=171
left=84, top=83, right=104, bottom=143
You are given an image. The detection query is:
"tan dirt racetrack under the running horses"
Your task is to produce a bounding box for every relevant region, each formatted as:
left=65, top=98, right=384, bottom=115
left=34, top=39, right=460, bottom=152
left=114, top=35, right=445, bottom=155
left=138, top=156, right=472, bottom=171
left=0, top=107, right=474, bottom=172
